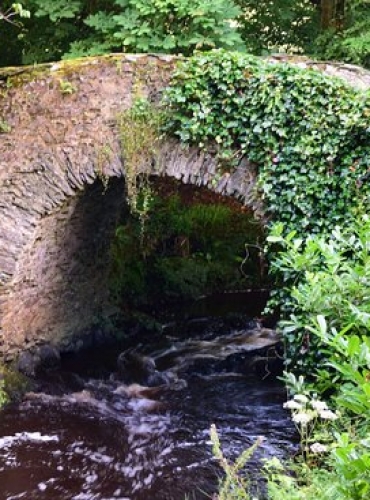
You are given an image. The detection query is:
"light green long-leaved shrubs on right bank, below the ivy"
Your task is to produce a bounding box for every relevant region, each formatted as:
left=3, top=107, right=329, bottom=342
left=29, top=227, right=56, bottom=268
left=262, top=220, right=370, bottom=500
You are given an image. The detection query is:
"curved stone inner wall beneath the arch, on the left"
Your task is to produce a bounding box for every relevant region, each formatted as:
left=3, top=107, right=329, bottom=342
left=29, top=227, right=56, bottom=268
left=2, top=180, right=124, bottom=356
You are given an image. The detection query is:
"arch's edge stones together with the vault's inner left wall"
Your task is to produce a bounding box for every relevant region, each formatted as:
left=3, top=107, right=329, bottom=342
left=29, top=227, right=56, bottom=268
left=0, top=136, right=262, bottom=360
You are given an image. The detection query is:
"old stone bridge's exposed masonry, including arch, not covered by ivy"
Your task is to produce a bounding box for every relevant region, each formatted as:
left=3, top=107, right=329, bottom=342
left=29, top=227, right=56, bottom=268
left=0, top=55, right=370, bottom=360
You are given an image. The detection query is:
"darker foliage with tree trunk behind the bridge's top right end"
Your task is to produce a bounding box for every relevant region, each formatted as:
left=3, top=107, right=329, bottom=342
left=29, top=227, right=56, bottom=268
left=237, top=0, right=370, bottom=67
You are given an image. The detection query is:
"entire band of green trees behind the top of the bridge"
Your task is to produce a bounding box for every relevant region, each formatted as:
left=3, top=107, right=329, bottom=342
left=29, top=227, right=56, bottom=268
left=0, top=0, right=370, bottom=66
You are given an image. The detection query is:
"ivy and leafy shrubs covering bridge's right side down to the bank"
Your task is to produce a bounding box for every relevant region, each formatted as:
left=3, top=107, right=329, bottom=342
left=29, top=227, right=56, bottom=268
left=161, top=44, right=370, bottom=500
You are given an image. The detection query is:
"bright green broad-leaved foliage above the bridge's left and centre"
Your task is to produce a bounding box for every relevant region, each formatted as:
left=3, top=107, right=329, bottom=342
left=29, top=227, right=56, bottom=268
left=0, top=0, right=244, bottom=65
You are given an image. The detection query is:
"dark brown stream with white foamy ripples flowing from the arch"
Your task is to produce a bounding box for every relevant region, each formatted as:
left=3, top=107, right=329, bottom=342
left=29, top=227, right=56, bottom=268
left=0, top=294, right=294, bottom=500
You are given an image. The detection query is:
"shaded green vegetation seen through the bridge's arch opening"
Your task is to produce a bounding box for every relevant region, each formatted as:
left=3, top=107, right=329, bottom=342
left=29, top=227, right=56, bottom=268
left=108, top=190, right=263, bottom=306
